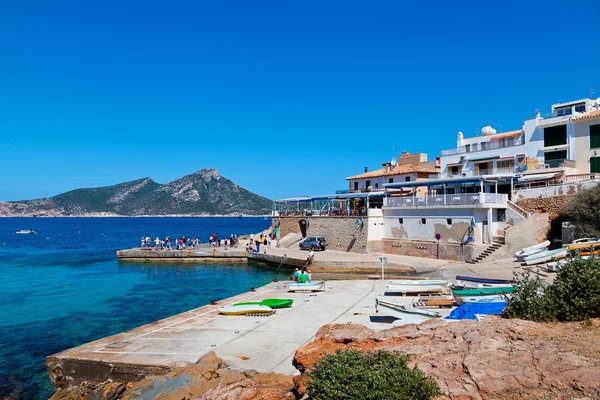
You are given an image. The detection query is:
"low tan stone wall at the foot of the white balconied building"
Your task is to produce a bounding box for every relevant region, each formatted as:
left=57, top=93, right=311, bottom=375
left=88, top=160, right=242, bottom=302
left=383, top=239, right=478, bottom=261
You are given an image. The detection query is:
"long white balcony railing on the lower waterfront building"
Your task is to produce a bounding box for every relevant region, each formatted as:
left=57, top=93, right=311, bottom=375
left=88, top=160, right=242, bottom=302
left=383, top=193, right=508, bottom=208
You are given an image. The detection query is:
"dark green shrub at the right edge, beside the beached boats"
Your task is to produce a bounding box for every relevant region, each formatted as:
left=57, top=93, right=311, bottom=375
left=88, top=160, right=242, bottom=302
left=504, top=257, right=600, bottom=322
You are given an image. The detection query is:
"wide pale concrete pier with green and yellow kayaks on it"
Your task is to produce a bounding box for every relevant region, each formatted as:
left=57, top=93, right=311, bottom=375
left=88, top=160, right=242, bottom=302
left=46, top=280, right=449, bottom=389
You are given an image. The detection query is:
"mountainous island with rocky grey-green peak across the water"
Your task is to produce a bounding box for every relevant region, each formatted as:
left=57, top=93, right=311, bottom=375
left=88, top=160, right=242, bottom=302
left=0, top=168, right=273, bottom=217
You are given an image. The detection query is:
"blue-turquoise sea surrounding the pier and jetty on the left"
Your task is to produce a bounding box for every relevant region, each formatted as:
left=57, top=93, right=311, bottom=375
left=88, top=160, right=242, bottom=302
left=0, top=217, right=287, bottom=399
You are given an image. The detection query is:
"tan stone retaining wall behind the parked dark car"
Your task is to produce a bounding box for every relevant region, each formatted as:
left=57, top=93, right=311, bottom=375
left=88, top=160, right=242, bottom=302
left=273, top=216, right=369, bottom=253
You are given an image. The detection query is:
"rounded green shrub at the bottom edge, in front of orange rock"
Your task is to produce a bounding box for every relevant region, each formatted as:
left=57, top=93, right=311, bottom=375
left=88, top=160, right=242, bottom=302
left=307, top=349, right=440, bottom=400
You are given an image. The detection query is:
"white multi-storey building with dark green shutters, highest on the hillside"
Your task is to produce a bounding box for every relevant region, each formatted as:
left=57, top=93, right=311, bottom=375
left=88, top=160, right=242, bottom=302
left=440, top=95, right=600, bottom=195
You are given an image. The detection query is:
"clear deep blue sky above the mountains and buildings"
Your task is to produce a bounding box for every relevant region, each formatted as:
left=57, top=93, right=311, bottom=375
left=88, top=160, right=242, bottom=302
left=0, top=0, right=600, bottom=200
